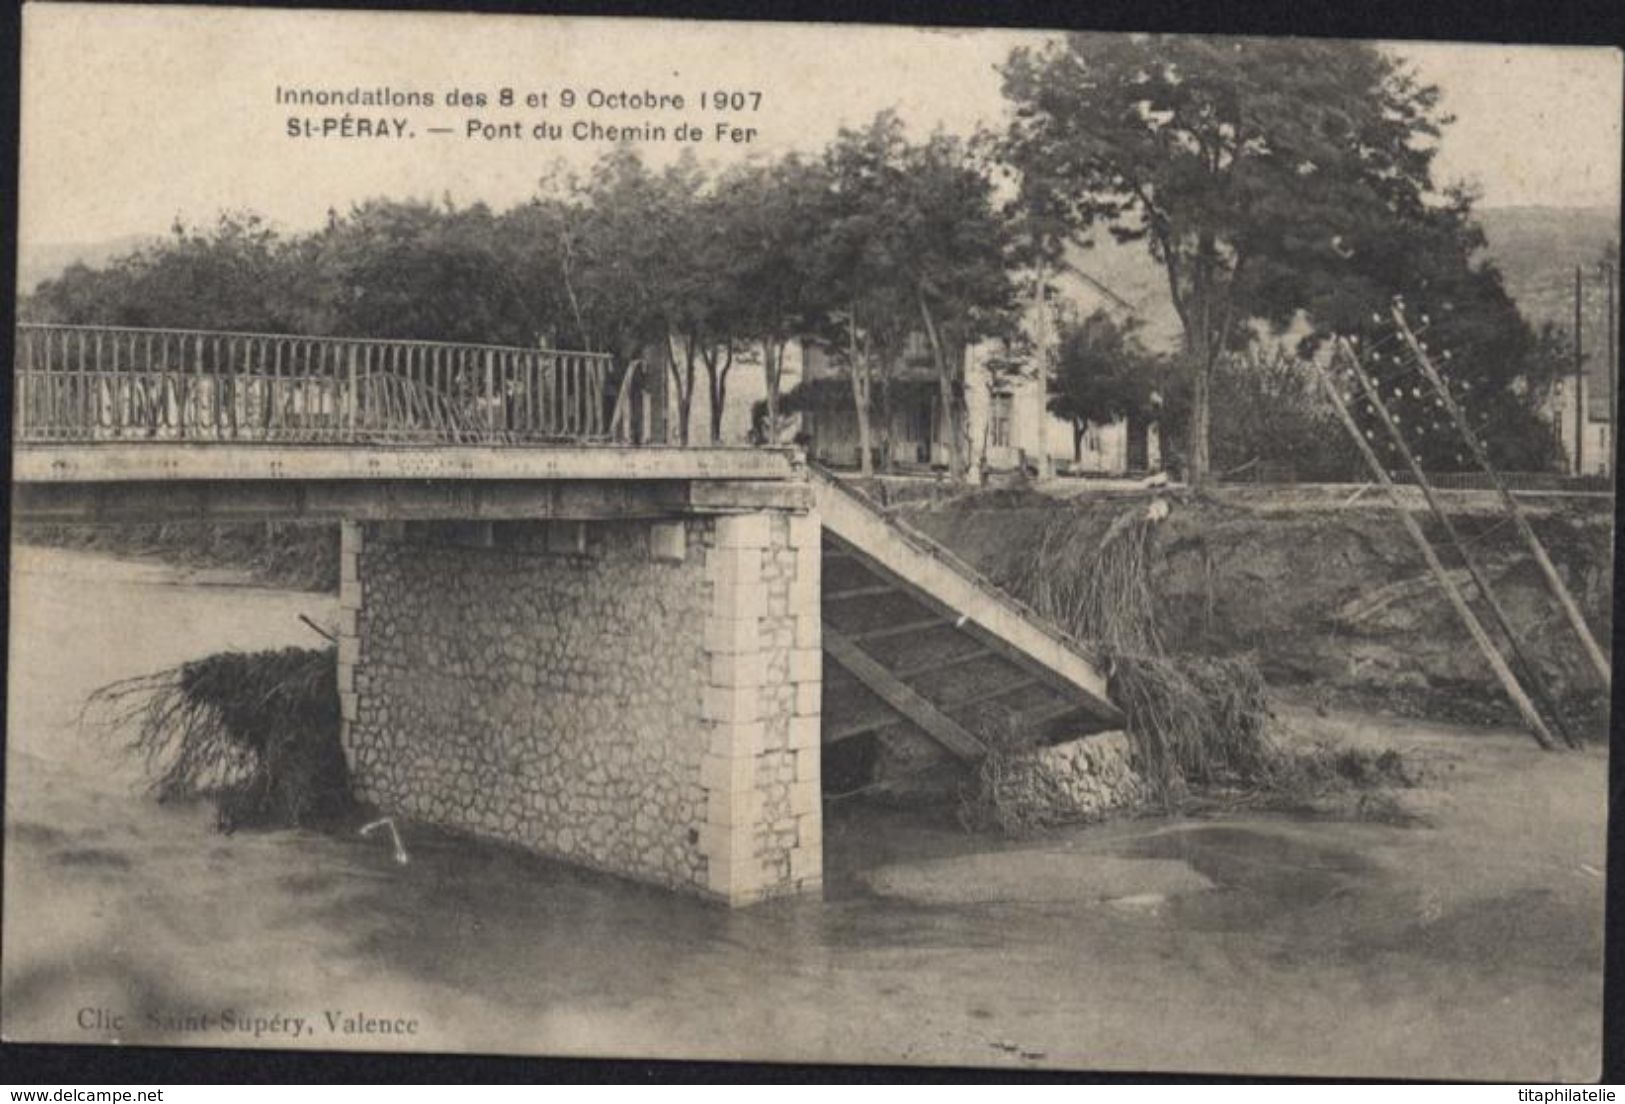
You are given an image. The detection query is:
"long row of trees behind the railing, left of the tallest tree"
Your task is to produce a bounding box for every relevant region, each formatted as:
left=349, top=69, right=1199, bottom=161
left=24, top=112, right=1017, bottom=470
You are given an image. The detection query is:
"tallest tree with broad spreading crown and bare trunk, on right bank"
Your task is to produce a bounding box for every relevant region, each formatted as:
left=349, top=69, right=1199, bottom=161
left=1003, top=34, right=1446, bottom=485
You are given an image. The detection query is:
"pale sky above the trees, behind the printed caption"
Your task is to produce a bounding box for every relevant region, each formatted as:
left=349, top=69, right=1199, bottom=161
left=20, top=3, right=1622, bottom=244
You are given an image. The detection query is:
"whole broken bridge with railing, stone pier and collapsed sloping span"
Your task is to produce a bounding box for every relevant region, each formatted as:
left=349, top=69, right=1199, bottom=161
left=13, top=324, right=1121, bottom=904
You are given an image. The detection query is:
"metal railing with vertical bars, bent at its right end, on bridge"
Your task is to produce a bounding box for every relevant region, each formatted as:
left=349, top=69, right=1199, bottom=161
left=13, top=322, right=629, bottom=444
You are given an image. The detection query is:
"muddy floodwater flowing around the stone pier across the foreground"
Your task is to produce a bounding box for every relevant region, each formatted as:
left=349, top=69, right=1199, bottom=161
left=0, top=548, right=1606, bottom=1081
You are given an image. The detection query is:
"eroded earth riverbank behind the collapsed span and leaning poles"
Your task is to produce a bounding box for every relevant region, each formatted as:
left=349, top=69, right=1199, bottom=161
left=904, top=486, right=1614, bottom=740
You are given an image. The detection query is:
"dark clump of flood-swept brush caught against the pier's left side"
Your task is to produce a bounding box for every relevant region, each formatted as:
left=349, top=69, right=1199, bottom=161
left=86, top=647, right=353, bottom=832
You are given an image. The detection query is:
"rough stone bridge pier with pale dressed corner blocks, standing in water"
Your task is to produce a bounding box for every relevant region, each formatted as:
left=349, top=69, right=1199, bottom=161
left=338, top=506, right=822, bottom=906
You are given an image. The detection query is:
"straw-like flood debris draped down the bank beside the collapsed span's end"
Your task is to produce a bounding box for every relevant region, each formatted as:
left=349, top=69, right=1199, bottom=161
left=960, top=501, right=1449, bottom=834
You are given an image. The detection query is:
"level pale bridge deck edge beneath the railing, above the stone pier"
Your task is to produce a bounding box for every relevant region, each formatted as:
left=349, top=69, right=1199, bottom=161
left=11, top=442, right=811, bottom=524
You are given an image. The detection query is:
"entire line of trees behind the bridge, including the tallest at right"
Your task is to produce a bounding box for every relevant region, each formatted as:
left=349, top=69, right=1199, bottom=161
left=24, top=34, right=1573, bottom=483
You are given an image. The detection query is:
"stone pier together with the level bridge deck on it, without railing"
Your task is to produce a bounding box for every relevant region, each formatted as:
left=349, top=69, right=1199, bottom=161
left=13, top=441, right=822, bottom=904
